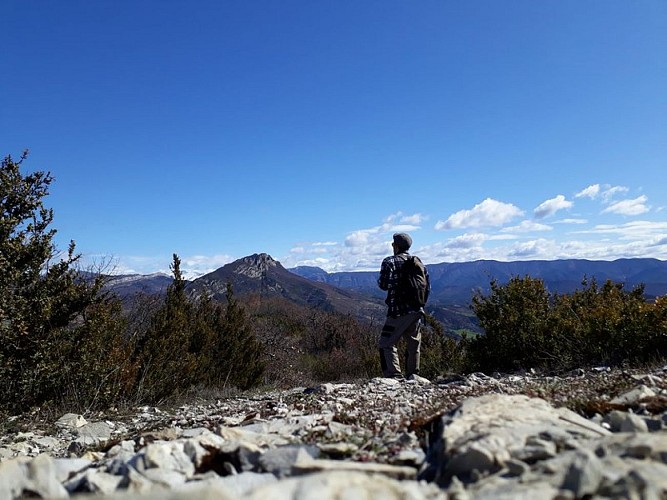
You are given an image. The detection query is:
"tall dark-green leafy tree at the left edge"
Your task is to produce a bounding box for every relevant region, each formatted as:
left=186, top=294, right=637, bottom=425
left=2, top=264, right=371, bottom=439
left=0, top=152, right=130, bottom=410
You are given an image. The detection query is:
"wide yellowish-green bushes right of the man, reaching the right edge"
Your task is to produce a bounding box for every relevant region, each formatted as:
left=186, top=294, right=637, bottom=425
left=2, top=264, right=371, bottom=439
left=468, top=277, right=667, bottom=371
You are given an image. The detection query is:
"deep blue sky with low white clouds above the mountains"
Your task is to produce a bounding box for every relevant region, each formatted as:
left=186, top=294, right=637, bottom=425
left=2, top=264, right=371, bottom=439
left=0, top=0, right=667, bottom=276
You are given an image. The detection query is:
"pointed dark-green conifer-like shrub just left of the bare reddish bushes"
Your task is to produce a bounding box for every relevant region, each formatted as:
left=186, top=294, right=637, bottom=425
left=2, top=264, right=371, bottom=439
left=135, top=254, right=264, bottom=402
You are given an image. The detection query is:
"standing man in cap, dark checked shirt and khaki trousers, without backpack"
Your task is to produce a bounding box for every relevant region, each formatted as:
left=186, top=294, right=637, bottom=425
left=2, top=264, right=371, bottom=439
left=378, top=233, right=430, bottom=378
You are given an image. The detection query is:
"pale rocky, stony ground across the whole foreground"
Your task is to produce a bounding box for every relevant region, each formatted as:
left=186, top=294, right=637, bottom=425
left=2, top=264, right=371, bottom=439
left=0, top=368, right=667, bottom=500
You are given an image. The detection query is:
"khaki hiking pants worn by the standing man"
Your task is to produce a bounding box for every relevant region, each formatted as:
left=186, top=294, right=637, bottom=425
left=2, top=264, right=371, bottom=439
left=378, top=312, right=423, bottom=377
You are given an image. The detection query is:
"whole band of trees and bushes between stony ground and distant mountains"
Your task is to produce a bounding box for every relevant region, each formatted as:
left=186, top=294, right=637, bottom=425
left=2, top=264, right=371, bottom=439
left=0, top=154, right=667, bottom=413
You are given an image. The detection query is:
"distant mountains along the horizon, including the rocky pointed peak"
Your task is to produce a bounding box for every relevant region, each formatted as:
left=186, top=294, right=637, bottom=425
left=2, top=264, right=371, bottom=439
left=108, top=253, right=667, bottom=331
